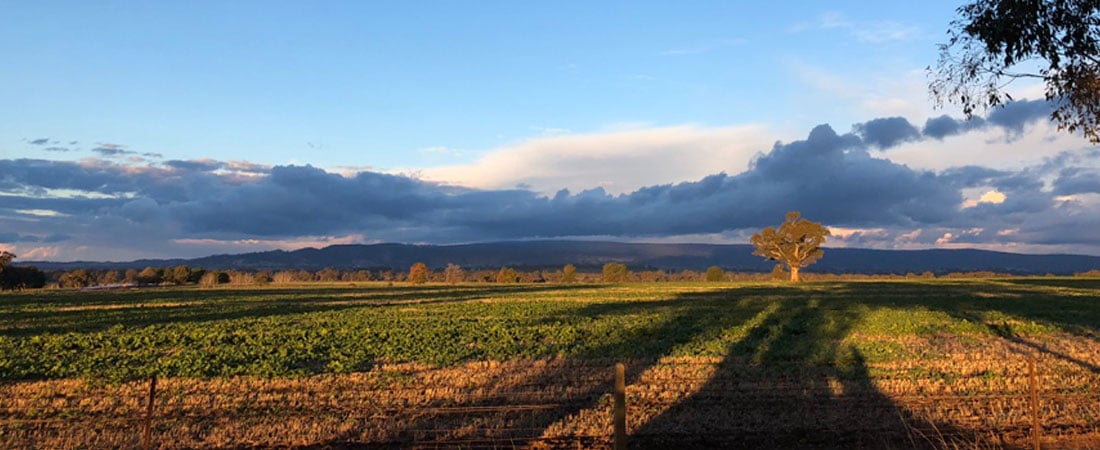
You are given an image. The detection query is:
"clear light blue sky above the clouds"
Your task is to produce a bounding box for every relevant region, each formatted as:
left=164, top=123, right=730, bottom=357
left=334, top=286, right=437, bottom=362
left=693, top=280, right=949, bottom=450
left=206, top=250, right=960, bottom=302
left=0, top=1, right=955, bottom=169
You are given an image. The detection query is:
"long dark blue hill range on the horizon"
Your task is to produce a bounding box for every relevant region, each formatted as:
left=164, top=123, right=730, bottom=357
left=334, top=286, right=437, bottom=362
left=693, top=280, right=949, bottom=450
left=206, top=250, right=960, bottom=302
left=23, top=241, right=1100, bottom=275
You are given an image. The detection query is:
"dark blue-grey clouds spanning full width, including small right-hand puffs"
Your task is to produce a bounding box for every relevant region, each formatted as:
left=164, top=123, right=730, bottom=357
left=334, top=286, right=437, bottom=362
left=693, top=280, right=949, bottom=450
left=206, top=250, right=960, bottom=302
left=0, top=102, right=1100, bottom=256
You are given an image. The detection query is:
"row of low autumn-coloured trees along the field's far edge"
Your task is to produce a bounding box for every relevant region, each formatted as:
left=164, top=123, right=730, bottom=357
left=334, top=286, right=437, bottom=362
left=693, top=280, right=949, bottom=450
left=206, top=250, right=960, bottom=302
left=15, top=263, right=1100, bottom=289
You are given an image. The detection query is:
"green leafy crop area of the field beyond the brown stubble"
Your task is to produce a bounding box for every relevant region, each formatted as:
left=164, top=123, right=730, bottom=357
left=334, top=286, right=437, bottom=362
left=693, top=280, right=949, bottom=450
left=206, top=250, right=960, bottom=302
left=0, top=278, right=1100, bottom=380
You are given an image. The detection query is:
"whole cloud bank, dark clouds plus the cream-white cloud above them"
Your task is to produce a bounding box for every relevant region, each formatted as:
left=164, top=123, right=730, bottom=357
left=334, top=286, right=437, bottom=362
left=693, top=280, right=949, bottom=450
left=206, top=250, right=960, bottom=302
left=0, top=102, right=1100, bottom=260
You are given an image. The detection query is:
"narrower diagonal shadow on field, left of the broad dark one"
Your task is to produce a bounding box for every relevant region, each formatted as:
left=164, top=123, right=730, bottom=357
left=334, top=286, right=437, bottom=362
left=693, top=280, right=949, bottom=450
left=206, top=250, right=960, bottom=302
left=320, top=288, right=777, bottom=449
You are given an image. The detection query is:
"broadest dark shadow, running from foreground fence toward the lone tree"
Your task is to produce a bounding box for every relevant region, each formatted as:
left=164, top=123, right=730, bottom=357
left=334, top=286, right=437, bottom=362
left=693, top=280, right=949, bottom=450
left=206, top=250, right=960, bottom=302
left=630, top=288, right=957, bottom=449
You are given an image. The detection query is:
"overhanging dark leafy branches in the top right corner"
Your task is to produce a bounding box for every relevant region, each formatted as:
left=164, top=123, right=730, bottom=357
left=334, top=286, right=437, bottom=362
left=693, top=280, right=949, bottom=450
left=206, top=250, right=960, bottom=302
left=928, top=0, right=1100, bottom=143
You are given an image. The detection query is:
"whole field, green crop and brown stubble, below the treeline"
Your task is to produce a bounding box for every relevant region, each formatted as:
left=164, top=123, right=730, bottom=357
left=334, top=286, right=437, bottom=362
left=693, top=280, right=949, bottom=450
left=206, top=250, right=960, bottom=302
left=0, top=278, right=1100, bottom=448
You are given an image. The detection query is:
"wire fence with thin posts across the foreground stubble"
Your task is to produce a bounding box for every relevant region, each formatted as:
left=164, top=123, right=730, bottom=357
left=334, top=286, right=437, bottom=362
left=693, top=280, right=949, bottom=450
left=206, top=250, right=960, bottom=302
left=0, top=355, right=1100, bottom=449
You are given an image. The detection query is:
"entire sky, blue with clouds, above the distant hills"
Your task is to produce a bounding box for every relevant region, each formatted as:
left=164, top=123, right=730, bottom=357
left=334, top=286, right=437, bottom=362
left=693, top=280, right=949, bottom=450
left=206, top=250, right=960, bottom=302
left=0, top=1, right=1100, bottom=261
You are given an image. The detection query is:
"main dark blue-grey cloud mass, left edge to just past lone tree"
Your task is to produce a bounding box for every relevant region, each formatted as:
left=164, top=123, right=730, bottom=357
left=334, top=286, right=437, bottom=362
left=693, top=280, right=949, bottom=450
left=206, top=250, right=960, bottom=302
left=0, top=122, right=961, bottom=242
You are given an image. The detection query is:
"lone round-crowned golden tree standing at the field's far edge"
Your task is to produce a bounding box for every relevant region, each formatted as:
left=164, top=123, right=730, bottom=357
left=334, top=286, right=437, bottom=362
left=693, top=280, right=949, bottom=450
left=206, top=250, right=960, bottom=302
left=751, top=211, right=829, bottom=283
